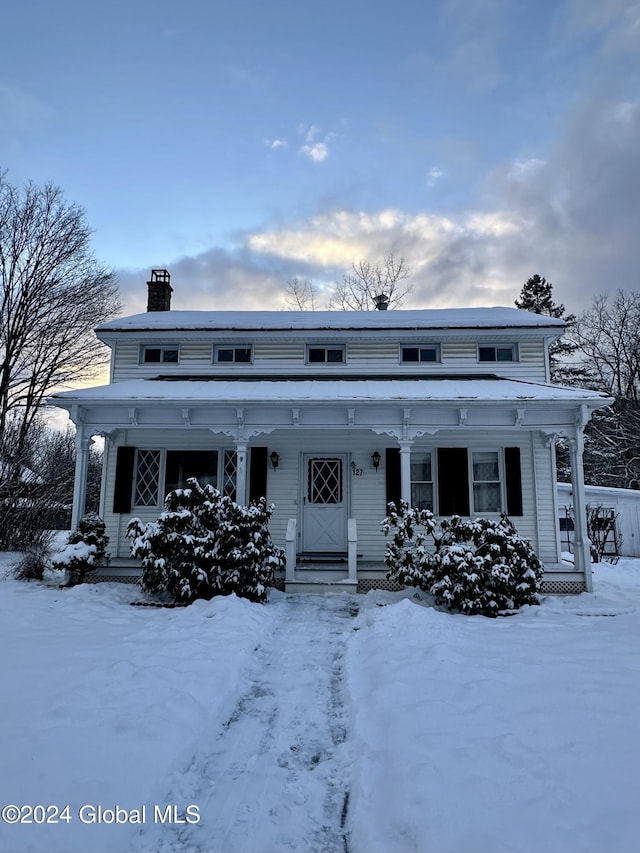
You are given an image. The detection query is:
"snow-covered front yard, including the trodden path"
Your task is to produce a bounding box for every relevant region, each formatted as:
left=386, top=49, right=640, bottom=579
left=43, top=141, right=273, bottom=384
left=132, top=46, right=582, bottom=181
left=0, top=555, right=640, bottom=853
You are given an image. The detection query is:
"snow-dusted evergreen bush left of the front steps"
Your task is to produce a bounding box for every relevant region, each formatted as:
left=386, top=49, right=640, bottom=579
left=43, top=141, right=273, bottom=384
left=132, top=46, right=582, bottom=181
left=127, top=479, right=284, bottom=604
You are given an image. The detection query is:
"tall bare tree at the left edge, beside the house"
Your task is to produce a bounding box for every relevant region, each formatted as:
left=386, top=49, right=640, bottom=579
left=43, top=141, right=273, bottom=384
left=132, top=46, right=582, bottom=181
left=0, top=174, right=120, bottom=456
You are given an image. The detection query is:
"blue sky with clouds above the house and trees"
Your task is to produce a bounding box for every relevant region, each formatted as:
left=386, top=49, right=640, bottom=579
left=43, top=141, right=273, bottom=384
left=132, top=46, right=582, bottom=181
left=0, top=0, right=640, bottom=313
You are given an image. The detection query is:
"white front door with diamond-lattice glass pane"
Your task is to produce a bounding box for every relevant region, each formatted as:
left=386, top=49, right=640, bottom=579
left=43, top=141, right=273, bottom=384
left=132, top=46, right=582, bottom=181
left=302, top=456, right=347, bottom=554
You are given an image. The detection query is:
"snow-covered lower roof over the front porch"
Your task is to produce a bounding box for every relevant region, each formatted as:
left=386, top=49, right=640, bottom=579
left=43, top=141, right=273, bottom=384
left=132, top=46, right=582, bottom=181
left=49, top=377, right=608, bottom=408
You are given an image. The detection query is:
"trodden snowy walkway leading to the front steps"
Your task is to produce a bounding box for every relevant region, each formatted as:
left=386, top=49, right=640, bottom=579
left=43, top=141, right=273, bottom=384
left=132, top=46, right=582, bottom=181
left=138, top=594, right=358, bottom=853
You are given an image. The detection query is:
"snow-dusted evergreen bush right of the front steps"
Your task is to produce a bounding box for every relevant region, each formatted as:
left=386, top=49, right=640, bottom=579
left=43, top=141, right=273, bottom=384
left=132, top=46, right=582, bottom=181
left=382, top=503, right=543, bottom=616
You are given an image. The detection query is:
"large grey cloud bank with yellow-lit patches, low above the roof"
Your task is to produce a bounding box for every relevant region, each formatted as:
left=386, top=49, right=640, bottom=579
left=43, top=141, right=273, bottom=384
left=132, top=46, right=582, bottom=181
left=115, top=98, right=640, bottom=312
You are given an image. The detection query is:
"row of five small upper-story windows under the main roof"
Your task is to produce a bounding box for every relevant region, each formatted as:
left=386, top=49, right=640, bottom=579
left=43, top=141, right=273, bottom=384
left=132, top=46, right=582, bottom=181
left=140, top=344, right=518, bottom=364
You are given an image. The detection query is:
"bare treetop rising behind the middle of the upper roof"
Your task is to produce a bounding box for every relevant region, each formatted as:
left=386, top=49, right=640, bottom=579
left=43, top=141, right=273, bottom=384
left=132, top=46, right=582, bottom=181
left=329, top=253, right=412, bottom=311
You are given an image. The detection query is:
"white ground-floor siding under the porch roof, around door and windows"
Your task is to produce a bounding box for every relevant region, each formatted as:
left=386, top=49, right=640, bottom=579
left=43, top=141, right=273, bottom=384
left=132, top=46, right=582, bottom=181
left=104, top=429, right=544, bottom=564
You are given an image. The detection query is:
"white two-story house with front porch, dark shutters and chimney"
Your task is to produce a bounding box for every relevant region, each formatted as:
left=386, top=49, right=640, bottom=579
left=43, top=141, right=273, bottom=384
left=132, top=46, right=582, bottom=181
left=50, top=270, right=610, bottom=592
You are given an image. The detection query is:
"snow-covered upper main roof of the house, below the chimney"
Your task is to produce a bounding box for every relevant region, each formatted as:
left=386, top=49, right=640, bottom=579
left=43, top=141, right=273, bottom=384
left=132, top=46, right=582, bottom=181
left=98, top=307, right=565, bottom=332
